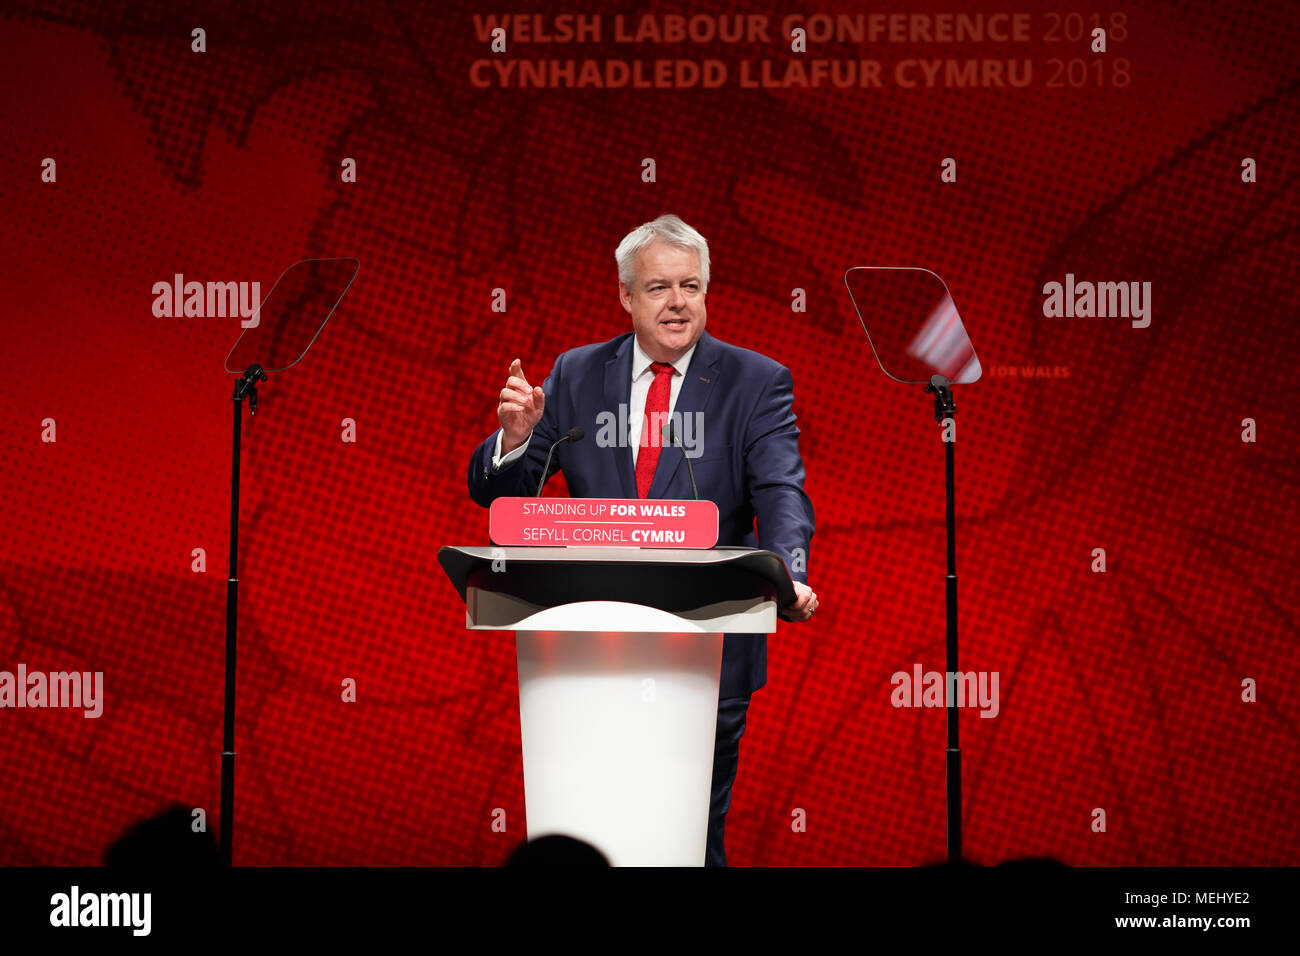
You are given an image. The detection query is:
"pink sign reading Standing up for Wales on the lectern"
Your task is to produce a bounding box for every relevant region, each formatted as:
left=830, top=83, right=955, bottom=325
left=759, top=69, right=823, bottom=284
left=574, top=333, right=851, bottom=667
left=488, top=498, right=718, bottom=548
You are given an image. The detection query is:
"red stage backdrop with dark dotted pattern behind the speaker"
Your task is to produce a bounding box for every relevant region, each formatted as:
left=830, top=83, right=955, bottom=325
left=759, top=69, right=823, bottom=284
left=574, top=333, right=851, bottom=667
left=0, top=0, right=1300, bottom=865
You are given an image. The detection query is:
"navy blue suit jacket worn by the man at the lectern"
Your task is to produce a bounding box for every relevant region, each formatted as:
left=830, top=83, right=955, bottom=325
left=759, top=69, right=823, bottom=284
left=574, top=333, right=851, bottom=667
left=469, top=332, right=813, bottom=697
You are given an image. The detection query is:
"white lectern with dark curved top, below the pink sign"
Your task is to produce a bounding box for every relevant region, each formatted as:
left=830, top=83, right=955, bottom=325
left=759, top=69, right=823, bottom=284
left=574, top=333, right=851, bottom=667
left=438, top=548, right=794, bottom=866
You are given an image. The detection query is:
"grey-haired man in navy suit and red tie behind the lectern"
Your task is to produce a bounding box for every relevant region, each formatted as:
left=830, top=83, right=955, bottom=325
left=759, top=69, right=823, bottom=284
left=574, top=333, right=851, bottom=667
left=469, top=216, right=818, bottom=866
